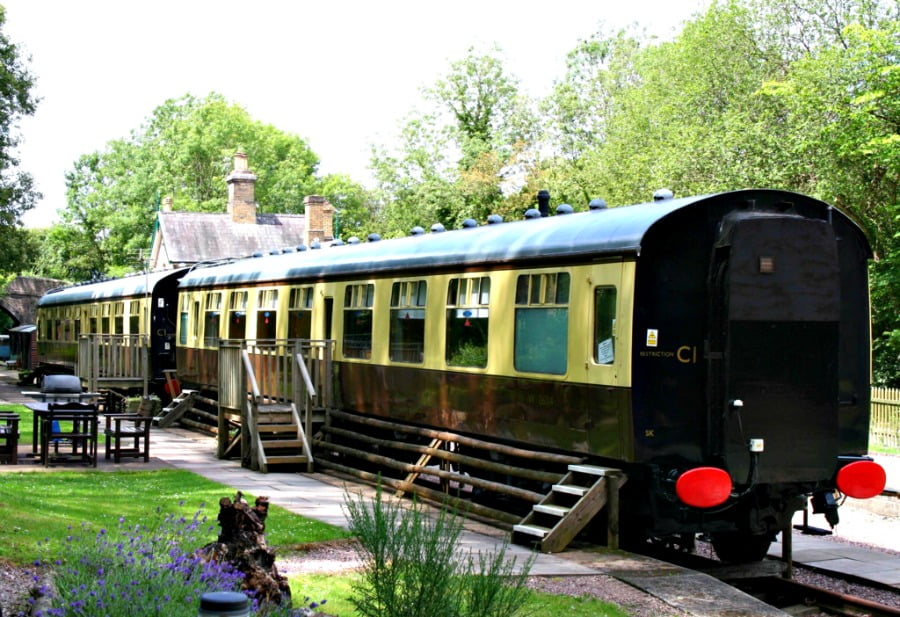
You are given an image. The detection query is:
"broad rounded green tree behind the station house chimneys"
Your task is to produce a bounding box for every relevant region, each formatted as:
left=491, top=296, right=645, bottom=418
left=40, top=94, right=318, bottom=280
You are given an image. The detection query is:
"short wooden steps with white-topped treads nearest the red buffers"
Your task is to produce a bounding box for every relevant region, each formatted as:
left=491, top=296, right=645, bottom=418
left=512, top=464, right=627, bottom=553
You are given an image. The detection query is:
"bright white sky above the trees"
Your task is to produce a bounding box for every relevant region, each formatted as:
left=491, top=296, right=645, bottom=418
left=0, top=0, right=707, bottom=227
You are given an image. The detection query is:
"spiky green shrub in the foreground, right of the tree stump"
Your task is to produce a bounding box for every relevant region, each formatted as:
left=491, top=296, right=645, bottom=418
left=345, top=486, right=534, bottom=617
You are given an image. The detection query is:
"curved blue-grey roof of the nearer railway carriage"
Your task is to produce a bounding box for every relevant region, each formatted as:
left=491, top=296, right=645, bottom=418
left=179, top=190, right=852, bottom=288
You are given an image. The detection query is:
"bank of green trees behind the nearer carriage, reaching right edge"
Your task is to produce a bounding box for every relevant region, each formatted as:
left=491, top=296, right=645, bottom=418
left=373, top=0, right=900, bottom=385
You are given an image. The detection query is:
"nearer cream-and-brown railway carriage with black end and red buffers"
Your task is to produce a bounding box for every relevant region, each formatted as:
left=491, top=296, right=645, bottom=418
left=177, top=190, right=884, bottom=558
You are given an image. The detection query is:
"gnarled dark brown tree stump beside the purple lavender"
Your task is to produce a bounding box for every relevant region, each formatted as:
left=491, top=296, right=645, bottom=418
left=200, top=491, right=291, bottom=606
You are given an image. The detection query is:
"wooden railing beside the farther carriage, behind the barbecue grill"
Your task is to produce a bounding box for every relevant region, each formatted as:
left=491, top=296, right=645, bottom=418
left=75, top=334, right=151, bottom=397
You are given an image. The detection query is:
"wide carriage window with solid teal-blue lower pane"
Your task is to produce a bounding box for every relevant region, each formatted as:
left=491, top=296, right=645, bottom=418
left=515, top=272, right=569, bottom=375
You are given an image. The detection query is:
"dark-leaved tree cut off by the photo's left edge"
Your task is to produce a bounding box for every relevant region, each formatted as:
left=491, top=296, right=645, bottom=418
left=0, top=5, right=40, bottom=272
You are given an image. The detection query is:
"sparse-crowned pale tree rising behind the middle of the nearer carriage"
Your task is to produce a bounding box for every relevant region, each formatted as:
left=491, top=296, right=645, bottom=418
left=371, top=49, right=539, bottom=235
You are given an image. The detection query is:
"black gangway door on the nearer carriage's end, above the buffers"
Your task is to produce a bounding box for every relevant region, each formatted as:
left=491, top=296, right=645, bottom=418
left=708, top=213, right=840, bottom=483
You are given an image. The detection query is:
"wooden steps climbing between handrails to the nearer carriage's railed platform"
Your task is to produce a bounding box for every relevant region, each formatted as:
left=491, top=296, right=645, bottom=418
left=252, top=403, right=313, bottom=473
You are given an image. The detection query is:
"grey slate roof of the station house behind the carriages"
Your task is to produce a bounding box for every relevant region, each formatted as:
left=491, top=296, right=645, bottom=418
left=157, top=212, right=306, bottom=265
